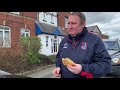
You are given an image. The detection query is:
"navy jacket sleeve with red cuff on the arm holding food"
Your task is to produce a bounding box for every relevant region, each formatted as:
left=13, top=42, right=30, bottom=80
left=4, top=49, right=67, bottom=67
left=81, top=39, right=111, bottom=78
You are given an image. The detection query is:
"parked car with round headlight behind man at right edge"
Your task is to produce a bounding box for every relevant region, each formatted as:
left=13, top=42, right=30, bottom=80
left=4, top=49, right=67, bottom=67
left=103, top=39, right=120, bottom=76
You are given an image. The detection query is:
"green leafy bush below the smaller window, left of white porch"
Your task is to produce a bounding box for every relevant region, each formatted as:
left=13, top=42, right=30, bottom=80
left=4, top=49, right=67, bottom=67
left=20, top=36, right=42, bottom=64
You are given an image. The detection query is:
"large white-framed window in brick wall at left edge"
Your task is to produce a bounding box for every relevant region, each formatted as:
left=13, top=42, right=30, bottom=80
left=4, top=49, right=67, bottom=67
left=0, top=25, right=11, bottom=47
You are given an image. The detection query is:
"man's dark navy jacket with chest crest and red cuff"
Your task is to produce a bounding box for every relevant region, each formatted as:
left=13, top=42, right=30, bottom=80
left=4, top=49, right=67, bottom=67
left=56, top=27, right=111, bottom=78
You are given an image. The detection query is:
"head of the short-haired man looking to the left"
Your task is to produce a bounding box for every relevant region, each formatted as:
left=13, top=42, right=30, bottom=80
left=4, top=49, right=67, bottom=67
left=68, top=12, right=86, bottom=37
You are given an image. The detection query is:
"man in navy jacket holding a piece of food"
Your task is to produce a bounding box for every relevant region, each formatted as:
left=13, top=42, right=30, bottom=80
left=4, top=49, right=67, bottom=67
left=53, top=12, right=111, bottom=78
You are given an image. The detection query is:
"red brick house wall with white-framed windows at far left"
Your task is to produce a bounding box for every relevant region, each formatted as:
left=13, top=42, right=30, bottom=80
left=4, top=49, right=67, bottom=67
left=0, top=12, right=37, bottom=48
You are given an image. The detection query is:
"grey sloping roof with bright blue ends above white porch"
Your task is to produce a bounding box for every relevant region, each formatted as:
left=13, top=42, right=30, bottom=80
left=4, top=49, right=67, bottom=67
left=35, top=21, right=65, bottom=36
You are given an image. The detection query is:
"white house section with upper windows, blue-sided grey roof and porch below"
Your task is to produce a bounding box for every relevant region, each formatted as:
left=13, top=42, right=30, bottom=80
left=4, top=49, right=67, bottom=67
left=35, top=12, right=66, bottom=55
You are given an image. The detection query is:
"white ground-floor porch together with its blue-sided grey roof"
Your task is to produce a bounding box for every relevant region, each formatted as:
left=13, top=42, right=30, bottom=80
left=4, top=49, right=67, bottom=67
left=35, top=22, right=65, bottom=55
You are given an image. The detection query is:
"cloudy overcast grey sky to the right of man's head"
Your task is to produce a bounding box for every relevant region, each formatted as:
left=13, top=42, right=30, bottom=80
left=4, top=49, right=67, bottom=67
left=83, top=12, right=120, bottom=39
